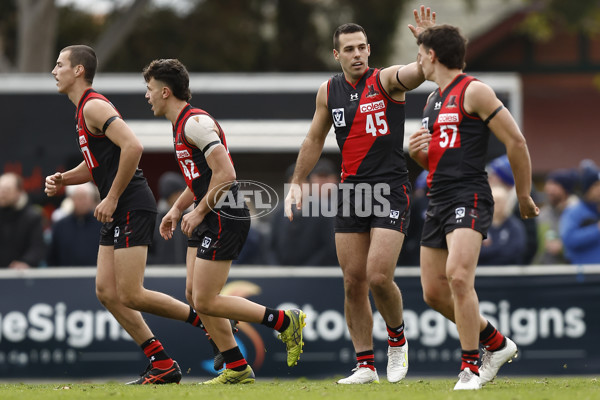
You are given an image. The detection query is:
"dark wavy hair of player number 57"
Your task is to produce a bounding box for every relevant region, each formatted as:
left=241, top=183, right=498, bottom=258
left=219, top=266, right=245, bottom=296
left=417, top=25, right=467, bottom=69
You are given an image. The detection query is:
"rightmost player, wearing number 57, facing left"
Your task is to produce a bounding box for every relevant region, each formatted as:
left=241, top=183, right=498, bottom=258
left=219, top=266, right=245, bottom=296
left=409, top=25, right=539, bottom=390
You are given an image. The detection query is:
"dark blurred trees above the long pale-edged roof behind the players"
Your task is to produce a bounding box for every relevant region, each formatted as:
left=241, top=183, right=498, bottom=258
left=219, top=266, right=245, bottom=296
left=0, top=0, right=405, bottom=72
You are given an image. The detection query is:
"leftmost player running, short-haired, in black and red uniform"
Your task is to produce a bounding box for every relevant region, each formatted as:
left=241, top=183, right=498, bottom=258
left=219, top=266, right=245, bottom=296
left=45, top=45, right=223, bottom=384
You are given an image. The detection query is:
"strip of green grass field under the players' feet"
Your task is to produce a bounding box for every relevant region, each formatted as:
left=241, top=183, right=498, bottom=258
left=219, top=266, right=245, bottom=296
left=0, top=377, right=600, bottom=400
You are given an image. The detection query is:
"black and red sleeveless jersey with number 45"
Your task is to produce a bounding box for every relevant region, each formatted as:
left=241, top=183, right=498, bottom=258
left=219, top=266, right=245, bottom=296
left=327, top=68, right=408, bottom=184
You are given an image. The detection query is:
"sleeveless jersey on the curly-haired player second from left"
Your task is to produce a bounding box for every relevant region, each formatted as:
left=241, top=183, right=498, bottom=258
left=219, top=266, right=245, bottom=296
left=173, top=104, right=239, bottom=202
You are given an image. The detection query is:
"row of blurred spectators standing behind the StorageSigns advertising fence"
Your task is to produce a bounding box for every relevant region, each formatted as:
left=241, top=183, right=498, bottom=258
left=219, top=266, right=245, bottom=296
left=0, top=156, right=600, bottom=269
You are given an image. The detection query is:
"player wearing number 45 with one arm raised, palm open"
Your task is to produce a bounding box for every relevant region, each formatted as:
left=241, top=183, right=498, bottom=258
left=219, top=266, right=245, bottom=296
left=285, top=6, right=435, bottom=384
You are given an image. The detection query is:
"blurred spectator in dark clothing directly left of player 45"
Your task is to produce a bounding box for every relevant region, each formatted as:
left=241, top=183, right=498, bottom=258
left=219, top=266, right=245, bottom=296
left=269, top=159, right=339, bottom=266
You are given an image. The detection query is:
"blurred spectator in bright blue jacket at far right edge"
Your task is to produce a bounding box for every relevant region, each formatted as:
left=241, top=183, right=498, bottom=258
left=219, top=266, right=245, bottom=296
left=560, top=160, right=600, bottom=264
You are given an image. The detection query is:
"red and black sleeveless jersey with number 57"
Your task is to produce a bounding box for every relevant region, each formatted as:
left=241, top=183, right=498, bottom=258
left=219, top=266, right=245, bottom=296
left=422, top=74, right=492, bottom=204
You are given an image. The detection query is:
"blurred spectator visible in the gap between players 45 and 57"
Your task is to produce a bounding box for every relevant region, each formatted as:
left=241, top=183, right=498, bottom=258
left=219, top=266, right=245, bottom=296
left=398, top=170, right=429, bottom=267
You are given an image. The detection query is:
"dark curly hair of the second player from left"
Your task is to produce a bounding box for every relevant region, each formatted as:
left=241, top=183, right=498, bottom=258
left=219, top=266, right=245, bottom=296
left=143, top=58, right=192, bottom=101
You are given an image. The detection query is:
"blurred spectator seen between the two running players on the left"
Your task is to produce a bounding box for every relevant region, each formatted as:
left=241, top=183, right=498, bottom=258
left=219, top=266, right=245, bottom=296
left=148, top=171, right=188, bottom=266
